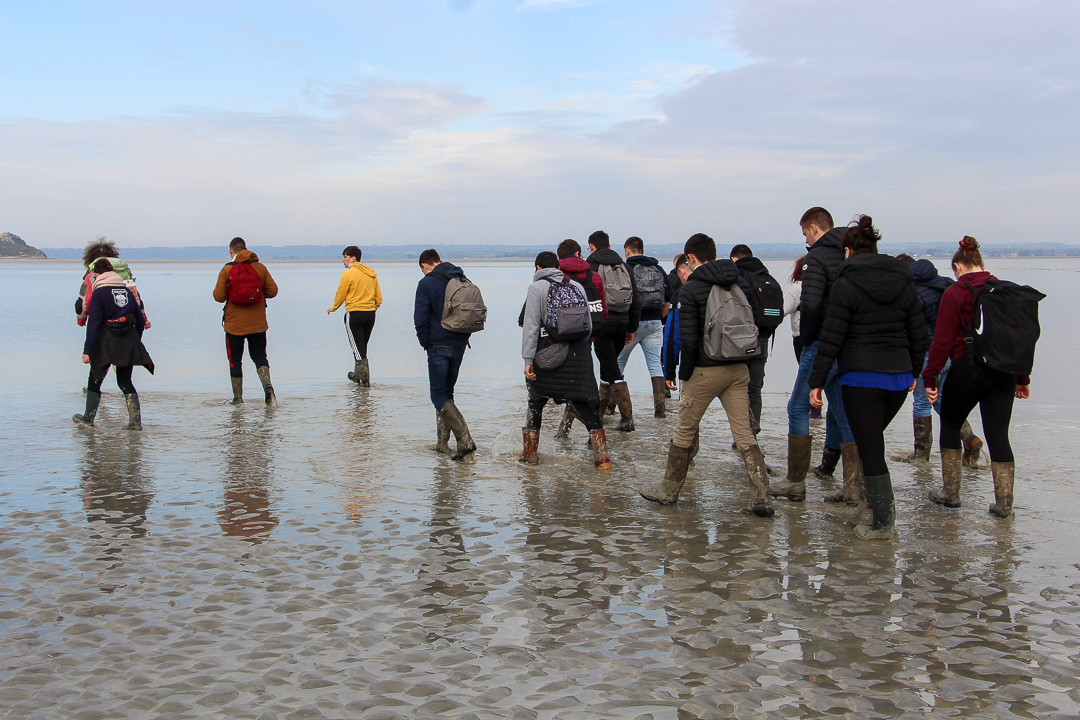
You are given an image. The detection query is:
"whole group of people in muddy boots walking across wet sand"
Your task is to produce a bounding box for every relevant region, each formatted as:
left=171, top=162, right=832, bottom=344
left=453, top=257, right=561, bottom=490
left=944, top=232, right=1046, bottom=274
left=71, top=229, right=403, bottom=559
left=73, top=207, right=1042, bottom=539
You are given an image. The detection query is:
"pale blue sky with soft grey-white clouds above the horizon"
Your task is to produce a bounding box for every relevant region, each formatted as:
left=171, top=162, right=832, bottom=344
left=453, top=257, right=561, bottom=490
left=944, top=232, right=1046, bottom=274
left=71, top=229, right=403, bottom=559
left=0, top=0, right=1080, bottom=249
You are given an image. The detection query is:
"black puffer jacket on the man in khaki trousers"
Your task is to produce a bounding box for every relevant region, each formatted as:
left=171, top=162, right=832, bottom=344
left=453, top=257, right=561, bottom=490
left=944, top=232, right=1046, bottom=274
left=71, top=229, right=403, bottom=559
left=678, top=258, right=755, bottom=381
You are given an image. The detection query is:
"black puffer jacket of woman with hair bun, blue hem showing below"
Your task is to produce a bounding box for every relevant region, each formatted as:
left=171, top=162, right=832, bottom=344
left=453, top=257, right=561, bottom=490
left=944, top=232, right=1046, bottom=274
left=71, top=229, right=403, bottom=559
left=804, top=253, right=927, bottom=388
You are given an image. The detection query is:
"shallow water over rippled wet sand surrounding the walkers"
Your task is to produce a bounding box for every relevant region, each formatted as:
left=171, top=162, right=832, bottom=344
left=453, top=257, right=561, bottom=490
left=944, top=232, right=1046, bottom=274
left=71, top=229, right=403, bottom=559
left=0, top=259, right=1080, bottom=720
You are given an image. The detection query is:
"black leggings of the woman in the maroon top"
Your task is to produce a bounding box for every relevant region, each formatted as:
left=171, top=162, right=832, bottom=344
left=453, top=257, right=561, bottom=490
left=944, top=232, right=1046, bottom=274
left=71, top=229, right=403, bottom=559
left=940, top=355, right=1016, bottom=462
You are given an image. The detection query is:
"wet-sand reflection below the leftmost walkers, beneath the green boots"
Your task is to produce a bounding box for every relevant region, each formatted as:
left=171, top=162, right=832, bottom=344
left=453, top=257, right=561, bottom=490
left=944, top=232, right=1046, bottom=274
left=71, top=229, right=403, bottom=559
left=79, top=432, right=153, bottom=558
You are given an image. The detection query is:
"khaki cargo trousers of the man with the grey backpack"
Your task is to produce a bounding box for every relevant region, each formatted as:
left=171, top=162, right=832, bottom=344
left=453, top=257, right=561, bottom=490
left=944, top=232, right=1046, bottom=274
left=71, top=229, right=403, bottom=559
left=672, top=363, right=757, bottom=449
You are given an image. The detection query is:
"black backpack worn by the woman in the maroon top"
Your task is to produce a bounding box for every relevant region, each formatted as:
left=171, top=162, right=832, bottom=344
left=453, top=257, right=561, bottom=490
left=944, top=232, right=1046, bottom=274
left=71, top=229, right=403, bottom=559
left=963, top=280, right=1047, bottom=375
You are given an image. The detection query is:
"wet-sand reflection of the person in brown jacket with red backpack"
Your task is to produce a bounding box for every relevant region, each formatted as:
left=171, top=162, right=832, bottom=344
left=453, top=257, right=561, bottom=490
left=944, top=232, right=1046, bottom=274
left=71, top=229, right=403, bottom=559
left=217, top=406, right=278, bottom=544
